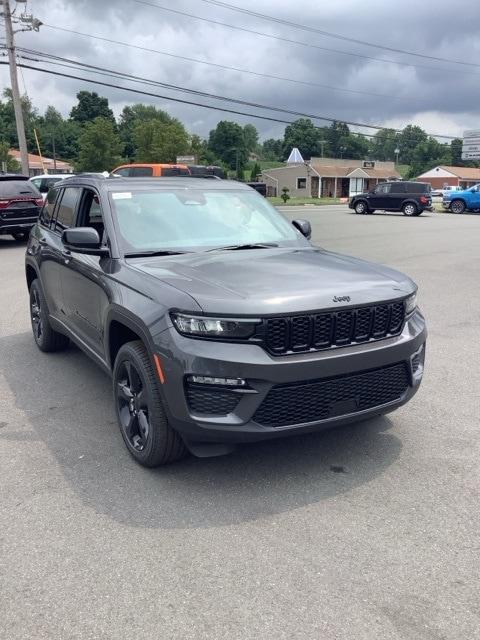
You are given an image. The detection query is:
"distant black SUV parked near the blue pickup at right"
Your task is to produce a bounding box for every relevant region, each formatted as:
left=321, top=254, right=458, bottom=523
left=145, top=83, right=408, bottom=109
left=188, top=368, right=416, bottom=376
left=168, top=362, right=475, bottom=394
left=348, top=180, right=432, bottom=216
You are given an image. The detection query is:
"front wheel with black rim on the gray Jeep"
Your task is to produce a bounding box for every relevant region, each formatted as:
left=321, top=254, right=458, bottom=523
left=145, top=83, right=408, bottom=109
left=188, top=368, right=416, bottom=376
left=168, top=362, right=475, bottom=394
left=113, top=340, right=187, bottom=467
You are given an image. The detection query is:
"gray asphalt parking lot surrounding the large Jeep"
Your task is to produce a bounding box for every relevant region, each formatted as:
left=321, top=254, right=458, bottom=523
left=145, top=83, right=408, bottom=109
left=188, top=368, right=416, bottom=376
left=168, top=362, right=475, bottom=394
left=0, top=206, right=480, bottom=640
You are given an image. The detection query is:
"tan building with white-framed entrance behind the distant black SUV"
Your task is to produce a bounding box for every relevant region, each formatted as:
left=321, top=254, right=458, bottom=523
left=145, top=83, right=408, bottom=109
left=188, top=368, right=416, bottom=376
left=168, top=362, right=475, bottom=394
left=261, top=158, right=401, bottom=198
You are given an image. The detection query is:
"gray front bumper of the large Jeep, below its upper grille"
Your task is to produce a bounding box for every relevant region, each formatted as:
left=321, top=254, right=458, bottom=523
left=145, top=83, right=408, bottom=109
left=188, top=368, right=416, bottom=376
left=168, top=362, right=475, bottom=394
left=156, top=310, right=427, bottom=444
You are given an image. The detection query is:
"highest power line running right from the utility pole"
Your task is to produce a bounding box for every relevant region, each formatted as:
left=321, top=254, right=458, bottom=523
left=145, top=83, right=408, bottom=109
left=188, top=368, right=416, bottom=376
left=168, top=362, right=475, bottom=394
left=37, top=24, right=424, bottom=102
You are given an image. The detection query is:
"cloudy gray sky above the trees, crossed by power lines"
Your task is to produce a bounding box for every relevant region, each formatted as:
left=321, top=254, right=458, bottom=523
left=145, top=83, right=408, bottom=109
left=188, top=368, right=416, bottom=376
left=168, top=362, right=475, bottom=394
left=0, top=0, right=480, bottom=139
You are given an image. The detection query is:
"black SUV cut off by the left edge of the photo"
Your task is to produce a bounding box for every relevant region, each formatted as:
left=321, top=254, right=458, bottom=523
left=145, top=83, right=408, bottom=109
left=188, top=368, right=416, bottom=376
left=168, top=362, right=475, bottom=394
left=0, top=173, right=43, bottom=240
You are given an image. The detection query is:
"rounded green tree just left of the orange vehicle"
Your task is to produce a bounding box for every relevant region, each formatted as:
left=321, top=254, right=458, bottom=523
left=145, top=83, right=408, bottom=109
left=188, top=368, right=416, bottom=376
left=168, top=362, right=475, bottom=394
left=75, top=117, right=122, bottom=171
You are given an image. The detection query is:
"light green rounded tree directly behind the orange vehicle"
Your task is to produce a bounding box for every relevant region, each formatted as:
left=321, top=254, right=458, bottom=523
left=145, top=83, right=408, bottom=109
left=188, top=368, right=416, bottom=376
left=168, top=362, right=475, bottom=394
left=133, top=119, right=189, bottom=162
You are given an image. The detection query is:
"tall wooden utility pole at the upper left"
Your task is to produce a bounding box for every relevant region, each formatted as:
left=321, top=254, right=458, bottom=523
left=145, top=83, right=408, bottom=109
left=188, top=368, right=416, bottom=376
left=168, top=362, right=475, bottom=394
left=1, top=0, right=42, bottom=176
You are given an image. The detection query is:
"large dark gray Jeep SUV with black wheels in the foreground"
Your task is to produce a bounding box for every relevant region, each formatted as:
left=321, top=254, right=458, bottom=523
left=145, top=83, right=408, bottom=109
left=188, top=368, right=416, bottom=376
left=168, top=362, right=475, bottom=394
left=26, top=175, right=426, bottom=466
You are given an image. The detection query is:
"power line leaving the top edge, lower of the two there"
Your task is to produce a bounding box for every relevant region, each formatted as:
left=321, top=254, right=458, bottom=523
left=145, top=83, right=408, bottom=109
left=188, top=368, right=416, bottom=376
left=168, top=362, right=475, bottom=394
left=133, top=0, right=480, bottom=76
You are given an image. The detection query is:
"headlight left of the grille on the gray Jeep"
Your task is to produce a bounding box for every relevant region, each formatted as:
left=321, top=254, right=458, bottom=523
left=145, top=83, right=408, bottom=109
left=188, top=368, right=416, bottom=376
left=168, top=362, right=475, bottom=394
left=170, top=313, right=259, bottom=339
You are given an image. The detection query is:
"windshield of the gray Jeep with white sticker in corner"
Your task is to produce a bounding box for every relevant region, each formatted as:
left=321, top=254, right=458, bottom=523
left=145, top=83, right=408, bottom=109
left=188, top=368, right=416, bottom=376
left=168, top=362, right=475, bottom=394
left=111, top=188, right=307, bottom=253
